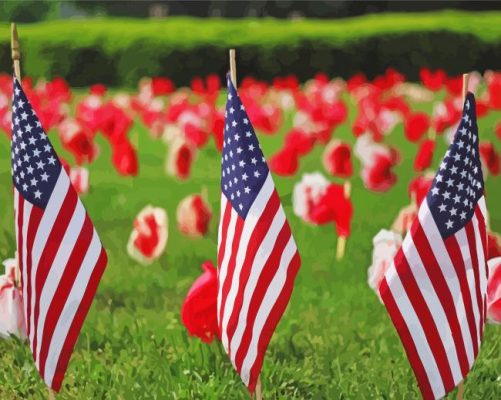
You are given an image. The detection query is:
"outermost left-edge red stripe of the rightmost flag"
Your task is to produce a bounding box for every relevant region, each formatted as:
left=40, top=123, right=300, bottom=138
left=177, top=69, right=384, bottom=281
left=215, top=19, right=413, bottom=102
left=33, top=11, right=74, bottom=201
left=379, top=278, right=435, bottom=399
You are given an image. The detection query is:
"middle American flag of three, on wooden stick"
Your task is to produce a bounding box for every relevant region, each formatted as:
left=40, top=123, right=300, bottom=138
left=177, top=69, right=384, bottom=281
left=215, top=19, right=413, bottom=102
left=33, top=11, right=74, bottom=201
left=217, top=78, right=301, bottom=392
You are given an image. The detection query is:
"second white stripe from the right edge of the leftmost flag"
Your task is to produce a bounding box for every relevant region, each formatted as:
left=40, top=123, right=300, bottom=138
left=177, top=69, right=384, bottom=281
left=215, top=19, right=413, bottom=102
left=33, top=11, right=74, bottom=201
left=33, top=201, right=86, bottom=367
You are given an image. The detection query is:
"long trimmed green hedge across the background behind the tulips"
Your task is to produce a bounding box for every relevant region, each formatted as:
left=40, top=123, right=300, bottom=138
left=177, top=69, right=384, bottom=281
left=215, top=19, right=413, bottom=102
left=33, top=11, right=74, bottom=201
left=0, top=11, right=501, bottom=87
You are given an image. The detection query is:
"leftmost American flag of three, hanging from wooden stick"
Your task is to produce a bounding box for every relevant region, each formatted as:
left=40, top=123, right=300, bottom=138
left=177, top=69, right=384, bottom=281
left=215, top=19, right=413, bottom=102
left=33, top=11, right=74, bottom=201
left=11, top=78, right=107, bottom=391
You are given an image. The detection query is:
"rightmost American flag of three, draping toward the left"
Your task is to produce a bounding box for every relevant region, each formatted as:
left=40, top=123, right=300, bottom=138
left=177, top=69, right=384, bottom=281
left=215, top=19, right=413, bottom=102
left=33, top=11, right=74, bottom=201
left=379, top=93, right=488, bottom=399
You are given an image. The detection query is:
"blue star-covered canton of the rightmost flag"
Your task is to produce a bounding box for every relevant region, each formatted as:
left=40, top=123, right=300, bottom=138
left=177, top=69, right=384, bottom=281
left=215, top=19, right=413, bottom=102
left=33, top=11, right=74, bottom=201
left=427, top=93, right=484, bottom=239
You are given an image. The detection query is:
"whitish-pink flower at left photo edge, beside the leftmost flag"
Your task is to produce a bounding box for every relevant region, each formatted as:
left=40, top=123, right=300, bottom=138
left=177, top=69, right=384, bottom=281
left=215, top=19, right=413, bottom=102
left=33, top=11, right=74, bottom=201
left=0, top=258, right=26, bottom=340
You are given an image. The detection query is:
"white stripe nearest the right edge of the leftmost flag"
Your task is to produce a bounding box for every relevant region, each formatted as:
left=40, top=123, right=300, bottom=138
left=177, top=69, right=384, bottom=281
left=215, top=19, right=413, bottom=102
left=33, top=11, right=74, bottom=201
left=44, top=230, right=102, bottom=387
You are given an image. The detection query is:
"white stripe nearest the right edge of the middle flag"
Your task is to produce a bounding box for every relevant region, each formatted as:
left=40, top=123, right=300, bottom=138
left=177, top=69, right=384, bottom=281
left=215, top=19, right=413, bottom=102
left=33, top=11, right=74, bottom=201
left=240, top=236, right=297, bottom=385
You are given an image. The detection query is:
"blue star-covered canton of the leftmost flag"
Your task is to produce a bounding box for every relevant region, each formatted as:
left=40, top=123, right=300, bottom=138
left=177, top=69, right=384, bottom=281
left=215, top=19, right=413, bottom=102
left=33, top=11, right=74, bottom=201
left=11, top=78, right=61, bottom=208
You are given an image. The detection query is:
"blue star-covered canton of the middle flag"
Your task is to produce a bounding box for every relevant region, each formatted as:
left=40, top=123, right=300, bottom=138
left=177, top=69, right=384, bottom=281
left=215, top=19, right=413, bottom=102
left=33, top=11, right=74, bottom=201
left=221, top=77, right=270, bottom=219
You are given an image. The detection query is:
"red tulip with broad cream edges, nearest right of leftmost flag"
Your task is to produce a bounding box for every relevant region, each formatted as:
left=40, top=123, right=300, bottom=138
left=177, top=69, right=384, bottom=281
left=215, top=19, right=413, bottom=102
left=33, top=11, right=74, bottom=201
left=127, top=206, right=168, bottom=265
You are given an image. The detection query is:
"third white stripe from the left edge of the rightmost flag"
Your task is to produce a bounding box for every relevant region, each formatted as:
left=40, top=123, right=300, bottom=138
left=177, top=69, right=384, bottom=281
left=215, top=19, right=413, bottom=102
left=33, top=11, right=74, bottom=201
left=419, top=201, right=474, bottom=365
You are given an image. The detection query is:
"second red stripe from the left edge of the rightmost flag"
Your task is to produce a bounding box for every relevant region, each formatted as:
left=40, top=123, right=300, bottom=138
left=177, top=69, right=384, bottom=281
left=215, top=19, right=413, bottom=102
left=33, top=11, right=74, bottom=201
left=394, top=248, right=455, bottom=392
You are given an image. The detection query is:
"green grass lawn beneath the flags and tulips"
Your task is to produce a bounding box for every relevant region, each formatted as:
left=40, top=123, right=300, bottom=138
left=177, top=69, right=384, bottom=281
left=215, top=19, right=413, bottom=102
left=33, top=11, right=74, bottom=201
left=0, top=92, right=501, bottom=400
